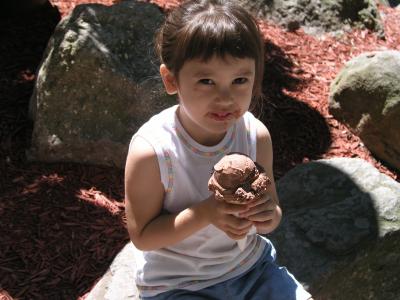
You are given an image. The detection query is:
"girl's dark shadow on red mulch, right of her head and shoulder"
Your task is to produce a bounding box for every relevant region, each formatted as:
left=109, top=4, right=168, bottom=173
left=256, top=41, right=332, bottom=178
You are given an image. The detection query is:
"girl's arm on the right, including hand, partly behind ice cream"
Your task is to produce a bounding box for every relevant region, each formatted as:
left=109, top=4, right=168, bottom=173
left=240, top=120, right=282, bottom=234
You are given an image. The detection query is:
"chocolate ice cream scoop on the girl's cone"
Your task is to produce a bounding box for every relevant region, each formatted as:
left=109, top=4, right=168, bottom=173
left=208, top=153, right=271, bottom=204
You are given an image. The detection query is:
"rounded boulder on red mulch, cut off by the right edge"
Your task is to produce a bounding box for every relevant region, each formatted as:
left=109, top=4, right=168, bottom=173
left=329, top=50, right=400, bottom=170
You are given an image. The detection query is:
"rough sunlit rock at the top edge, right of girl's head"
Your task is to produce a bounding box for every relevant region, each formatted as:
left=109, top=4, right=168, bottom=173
left=239, top=0, right=384, bottom=35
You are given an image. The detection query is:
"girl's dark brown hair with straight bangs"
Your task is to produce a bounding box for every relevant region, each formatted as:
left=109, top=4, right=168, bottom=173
left=155, top=0, right=264, bottom=104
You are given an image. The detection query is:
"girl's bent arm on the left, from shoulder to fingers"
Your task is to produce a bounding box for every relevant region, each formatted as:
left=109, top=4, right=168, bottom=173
left=125, top=138, right=252, bottom=251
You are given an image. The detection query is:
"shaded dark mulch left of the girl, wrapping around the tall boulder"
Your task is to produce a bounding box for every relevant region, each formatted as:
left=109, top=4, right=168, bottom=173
left=0, top=0, right=129, bottom=299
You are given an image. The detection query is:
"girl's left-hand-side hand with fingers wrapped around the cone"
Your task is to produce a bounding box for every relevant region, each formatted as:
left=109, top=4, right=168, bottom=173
left=205, top=195, right=253, bottom=240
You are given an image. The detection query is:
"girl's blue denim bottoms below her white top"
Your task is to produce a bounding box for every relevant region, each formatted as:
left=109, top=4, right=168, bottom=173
left=140, top=241, right=311, bottom=300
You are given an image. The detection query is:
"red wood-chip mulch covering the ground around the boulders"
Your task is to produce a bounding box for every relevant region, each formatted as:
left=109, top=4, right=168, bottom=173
left=0, top=0, right=400, bottom=300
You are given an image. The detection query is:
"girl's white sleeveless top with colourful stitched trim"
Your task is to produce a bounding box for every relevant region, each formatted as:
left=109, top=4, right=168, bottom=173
left=132, top=105, right=265, bottom=296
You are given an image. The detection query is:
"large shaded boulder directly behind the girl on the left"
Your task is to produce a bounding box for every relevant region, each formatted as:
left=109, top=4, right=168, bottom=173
left=29, top=1, right=175, bottom=167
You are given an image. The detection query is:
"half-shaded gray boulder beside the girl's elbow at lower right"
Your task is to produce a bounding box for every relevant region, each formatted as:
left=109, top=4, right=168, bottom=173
left=270, top=158, right=400, bottom=290
